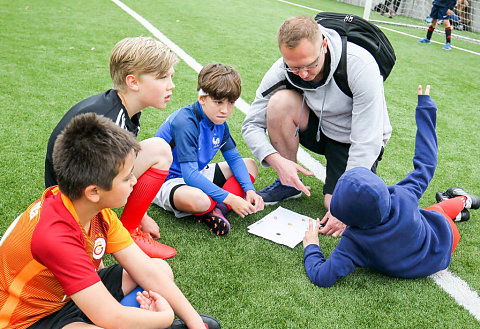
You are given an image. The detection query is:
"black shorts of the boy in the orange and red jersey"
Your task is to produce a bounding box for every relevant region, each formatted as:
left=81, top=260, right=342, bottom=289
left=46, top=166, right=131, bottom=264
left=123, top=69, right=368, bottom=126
left=29, top=264, right=124, bottom=329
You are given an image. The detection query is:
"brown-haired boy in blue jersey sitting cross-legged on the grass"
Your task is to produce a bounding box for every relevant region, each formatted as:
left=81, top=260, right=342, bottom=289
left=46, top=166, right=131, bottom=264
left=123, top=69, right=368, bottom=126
left=153, top=64, right=264, bottom=235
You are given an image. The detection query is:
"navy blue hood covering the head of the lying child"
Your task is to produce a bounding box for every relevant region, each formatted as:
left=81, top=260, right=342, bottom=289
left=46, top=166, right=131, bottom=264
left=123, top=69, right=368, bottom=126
left=330, top=167, right=390, bottom=228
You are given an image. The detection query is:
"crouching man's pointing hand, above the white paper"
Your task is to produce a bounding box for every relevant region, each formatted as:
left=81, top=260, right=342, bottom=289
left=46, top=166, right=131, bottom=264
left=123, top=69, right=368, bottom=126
left=265, top=153, right=313, bottom=196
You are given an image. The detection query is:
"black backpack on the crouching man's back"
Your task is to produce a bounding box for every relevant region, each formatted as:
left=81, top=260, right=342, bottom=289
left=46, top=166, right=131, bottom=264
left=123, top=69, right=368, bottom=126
left=315, top=12, right=396, bottom=97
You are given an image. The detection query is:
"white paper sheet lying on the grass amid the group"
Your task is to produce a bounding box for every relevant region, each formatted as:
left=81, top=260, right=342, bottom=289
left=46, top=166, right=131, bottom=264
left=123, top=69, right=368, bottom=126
left=248, top=207, right=310, bottom=248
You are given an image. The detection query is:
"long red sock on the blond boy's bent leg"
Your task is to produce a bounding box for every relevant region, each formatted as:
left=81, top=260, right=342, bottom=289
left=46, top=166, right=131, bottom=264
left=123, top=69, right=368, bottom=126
left=120, top=168, right=168, bottom=231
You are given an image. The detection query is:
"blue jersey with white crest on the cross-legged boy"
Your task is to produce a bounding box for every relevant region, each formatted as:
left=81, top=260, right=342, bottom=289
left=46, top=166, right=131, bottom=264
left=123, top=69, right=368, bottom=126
left=155, top=102, right=236, bottom=180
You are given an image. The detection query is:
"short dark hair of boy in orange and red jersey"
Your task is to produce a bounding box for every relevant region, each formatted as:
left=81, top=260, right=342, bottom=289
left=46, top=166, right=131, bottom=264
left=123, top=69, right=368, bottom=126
left=53, top=113, right=140, bottom=200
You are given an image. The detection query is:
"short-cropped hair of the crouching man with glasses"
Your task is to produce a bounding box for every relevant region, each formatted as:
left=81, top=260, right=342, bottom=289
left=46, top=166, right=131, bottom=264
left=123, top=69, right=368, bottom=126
left=277, top=16, right=321, bottom=49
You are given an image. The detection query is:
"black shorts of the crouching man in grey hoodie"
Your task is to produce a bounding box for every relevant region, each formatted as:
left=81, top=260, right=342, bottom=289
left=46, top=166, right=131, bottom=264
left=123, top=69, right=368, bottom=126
left=299, top=110, right=383, bottom=194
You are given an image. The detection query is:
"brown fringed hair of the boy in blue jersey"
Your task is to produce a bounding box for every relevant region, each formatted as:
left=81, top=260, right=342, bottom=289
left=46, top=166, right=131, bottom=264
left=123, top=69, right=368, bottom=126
left=197, top=64, right=242, bottom=102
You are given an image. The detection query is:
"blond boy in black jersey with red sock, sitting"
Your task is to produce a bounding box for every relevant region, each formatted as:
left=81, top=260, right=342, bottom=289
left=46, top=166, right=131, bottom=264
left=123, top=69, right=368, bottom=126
left=45, top=37, right=178, bottom=259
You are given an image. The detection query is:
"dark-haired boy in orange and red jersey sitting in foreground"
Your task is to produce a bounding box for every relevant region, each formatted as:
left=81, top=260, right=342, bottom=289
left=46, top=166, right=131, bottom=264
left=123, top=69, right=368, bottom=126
left=0, top=113, right=217, bottom=329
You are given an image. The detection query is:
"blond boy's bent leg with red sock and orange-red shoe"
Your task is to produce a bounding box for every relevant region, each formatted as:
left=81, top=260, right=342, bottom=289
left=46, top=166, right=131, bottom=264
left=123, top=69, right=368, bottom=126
left=120, top=137, right=177, bottom=258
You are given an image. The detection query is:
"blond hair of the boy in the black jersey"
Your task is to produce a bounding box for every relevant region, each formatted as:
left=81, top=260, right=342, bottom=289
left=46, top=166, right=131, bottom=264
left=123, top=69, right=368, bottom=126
left=110, top=37, right=179, bottom=90
